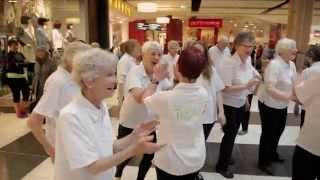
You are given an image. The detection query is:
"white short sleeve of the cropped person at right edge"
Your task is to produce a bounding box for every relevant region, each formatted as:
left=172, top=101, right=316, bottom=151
left=296, top=77, right=320, bottom=104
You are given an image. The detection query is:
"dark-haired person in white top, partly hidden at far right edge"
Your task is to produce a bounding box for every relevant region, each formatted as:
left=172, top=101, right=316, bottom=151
left=300, top=44, right=320, bottom=128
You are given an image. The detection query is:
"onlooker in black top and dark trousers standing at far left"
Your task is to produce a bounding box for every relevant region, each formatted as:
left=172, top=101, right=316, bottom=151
left=5, top=39, right=30, bottom=118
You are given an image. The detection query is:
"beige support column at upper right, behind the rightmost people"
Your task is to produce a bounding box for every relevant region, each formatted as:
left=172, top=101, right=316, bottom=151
left=288, top=0, right=314, bottom=70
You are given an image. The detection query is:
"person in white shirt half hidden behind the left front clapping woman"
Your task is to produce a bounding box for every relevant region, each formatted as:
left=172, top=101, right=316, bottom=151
left=28, top=42, right=90, bottom=160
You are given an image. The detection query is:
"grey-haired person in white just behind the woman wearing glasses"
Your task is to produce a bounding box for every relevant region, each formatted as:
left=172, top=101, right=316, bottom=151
left=208, top=36, right=231, bottom=73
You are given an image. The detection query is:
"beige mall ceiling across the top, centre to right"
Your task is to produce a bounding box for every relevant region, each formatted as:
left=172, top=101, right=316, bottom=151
left=127, top=0, right=320, bottom=25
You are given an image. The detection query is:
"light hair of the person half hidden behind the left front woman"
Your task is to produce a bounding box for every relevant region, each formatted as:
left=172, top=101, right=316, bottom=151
left=61, top=41, right=92, bottom=68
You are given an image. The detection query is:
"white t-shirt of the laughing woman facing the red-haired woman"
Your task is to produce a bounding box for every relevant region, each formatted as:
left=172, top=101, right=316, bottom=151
left=119, top=63, right=171, bottom=129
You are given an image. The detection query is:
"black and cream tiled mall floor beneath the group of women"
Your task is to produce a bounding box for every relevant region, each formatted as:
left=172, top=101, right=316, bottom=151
left=0, top=94, right=300, bottom=180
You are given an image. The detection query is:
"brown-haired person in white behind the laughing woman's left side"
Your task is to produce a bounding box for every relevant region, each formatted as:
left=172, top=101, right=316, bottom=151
left=117, top=39, right=141, bottom=106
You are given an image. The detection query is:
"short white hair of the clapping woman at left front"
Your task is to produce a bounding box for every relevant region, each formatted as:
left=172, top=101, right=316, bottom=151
left=72, top=48, right=116, bottom=89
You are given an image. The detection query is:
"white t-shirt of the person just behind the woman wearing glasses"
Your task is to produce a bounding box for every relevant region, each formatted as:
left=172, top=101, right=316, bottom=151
left=208, top=46, right=231, bottom=73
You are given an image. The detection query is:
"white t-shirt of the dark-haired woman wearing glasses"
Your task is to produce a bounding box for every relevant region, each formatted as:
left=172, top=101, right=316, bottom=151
left=219, top=53, right=255, bottom=108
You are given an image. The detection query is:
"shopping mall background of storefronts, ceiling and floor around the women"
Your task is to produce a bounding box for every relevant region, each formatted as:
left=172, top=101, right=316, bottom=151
left=0, top=0, right=320, bottom=180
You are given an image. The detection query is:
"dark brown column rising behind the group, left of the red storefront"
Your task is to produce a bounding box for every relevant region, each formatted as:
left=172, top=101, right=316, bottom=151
left=88, top=0, right=109, bottom=49
